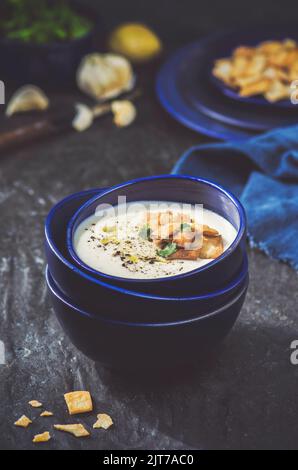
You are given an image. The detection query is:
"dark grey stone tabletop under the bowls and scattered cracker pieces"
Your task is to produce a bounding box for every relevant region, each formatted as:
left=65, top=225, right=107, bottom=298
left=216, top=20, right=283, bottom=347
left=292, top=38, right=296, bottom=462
left=0, top=1, right=298, bottom=449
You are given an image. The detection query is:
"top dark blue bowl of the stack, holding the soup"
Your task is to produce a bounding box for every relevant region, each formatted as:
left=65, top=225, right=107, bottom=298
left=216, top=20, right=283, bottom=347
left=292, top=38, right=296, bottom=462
left=67, top=175, right=246, bottom=296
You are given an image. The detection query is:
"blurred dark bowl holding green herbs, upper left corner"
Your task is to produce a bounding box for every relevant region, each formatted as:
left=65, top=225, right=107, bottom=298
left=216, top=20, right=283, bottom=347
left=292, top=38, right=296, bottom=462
left=0, top=2, right=103, bottom=88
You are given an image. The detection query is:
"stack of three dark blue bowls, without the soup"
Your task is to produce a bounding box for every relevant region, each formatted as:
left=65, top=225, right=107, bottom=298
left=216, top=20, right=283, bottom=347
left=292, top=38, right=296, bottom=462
left=45, top=175, right=248, bottom=370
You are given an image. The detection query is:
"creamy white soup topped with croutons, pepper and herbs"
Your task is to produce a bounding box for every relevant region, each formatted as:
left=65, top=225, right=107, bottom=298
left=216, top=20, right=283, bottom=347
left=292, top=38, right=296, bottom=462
left=74, top=201, right=237, bottom=279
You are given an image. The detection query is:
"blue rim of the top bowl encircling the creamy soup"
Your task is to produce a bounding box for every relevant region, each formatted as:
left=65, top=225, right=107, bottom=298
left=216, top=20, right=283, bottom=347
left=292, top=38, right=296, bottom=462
left=66, top=174, right=246, bottom=284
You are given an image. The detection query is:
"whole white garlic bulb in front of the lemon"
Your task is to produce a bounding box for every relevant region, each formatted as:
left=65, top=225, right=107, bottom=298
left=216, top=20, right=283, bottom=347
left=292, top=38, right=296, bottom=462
left=77, top=53, right=134, bottom=100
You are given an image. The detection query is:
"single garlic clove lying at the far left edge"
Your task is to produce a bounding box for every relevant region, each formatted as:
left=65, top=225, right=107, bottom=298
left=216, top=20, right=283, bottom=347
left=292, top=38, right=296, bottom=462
left=5, top=85, right=49, bottom=116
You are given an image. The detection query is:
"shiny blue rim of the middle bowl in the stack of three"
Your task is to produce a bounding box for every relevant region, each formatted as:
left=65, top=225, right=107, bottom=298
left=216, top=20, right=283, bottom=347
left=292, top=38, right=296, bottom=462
left=45, top=189, right=248, bottom=302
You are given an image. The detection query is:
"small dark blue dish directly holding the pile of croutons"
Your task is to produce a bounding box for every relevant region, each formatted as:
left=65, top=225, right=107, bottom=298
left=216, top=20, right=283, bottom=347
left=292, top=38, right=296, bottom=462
left=209, top=26, right=298, bottom=110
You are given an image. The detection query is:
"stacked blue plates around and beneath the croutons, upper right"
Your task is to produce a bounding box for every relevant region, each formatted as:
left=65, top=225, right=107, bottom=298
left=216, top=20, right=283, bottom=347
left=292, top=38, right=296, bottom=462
left=157, top=29, right=297, bottom=140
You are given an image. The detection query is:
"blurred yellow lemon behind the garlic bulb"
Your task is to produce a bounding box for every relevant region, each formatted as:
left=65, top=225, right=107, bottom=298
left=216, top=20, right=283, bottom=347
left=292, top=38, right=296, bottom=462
left=108, top=23, right=162, bottom=62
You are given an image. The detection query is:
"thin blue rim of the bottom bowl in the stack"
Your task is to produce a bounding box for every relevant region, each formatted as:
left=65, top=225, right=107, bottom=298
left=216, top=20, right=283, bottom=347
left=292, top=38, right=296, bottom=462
left=45, top=266, right=249, bottom=328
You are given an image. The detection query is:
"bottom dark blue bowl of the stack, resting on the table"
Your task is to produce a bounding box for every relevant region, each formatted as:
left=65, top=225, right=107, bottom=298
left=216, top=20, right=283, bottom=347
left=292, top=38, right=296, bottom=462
left=47, top=264, right=248, bottom=370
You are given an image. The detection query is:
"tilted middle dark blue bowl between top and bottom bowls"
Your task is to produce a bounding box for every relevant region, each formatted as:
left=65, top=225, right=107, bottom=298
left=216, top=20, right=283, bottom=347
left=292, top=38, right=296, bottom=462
left=45, top=189, right=248, bottom=322
